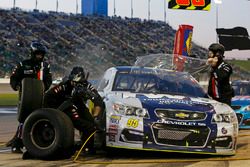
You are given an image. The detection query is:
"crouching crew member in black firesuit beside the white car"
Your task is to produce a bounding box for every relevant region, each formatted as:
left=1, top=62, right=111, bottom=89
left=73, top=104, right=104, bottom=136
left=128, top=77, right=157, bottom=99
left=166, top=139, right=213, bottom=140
left=44, top=67, right=103, bottom=152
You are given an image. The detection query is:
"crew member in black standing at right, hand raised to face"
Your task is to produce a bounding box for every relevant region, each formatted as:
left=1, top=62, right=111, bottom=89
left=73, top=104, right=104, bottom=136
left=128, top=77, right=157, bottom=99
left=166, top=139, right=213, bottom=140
left=207, top=43, right=234, bottom=106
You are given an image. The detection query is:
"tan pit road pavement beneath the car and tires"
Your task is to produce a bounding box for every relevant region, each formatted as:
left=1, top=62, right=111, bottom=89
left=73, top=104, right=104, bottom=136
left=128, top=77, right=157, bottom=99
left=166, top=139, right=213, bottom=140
left=0, top=108, right=250, bottom=167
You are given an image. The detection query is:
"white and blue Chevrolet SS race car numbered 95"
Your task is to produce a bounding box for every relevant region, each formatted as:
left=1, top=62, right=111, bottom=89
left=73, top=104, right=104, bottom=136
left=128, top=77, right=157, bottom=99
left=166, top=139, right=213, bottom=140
left=98, top=66, right=238, bottom=155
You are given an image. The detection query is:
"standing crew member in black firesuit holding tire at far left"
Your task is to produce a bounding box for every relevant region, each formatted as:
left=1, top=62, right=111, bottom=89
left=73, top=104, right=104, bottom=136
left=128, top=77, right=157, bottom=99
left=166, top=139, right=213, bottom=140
left=6, top=41, right=52, bottom=153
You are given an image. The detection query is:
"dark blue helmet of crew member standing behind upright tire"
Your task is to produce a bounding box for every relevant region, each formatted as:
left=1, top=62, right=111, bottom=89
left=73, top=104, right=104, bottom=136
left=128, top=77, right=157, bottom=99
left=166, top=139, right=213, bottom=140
left=30, top=41, right=47, bottom=62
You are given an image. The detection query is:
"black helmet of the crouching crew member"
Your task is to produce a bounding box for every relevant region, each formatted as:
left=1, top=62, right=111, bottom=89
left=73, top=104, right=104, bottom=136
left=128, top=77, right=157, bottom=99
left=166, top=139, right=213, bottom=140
left=69, top=66, right=86, bottom=83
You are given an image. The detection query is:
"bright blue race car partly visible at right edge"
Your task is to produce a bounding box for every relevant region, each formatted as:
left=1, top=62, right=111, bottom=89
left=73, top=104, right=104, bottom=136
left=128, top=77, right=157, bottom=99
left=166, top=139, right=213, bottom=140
left=232, top=80, right=250, bottom=129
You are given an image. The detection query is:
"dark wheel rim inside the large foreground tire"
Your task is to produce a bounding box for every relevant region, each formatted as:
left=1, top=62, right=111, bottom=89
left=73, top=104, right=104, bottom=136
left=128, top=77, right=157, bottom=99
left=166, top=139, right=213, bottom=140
left=31, top=119, right=56, bottom=149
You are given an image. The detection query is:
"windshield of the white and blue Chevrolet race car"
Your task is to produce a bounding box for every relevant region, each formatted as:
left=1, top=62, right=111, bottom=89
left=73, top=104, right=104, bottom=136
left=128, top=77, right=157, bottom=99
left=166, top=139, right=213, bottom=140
left=112, top=68, right=205, bottom=97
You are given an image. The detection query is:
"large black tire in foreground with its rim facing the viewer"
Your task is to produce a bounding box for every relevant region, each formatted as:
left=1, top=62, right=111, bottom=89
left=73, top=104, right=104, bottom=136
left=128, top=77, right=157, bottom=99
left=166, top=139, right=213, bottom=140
left=23, top=108, right=74, bottom=159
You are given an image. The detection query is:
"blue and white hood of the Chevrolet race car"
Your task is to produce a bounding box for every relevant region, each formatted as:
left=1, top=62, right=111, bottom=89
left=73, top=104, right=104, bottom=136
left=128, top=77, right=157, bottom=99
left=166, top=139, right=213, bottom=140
left=106, top=92, right=233, bottom=113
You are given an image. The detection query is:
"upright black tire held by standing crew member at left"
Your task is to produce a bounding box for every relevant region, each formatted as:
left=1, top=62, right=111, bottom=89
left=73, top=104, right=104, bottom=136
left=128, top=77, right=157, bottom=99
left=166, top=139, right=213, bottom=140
left=17, top=78, right=44, bottom=123
